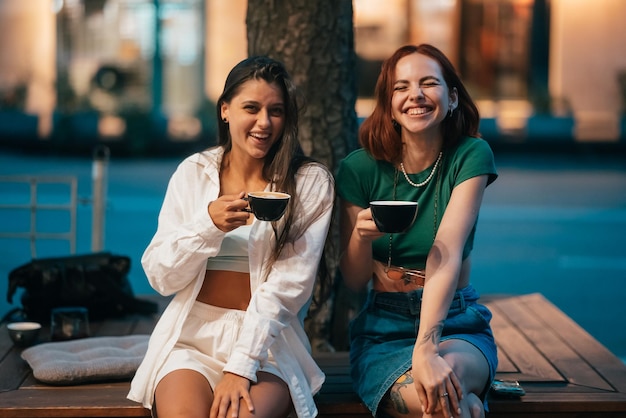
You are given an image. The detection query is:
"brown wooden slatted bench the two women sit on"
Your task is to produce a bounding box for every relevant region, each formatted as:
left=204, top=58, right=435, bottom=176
left=0, top=294, right=626, bottom=418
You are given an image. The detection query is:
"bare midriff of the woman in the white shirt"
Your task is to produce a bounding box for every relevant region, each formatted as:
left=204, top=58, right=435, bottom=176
left=196, top=270, right=251, bottom=311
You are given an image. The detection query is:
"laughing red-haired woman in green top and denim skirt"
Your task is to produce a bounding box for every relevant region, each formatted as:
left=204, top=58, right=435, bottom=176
left=337, top=44, right=497, bottom=417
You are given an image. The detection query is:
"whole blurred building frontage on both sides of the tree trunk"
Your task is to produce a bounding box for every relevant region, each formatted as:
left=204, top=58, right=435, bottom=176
left=0, top=0, right=626, bottom=153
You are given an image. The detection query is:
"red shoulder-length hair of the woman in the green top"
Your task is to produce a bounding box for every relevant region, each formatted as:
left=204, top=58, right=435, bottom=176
left=359, top=44, right=480, bottom=163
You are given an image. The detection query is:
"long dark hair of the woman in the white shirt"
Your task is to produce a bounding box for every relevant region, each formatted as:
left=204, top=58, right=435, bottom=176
left=216, top=56, right=330, bottom=300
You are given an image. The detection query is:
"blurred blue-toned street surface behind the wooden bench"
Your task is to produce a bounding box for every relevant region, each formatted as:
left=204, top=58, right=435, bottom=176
left=0, top=145, right=626, bottom=361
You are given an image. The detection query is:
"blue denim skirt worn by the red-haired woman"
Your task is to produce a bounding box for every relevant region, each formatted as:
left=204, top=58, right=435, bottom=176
left=350, top=286, right=498, bottom=415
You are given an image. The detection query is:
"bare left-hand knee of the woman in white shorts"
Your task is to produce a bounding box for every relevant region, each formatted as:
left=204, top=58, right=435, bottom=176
left=154, top=369, right=213, bottom=418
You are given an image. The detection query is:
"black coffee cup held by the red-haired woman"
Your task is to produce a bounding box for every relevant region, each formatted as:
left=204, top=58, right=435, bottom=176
left=370, top=200, right=417, bottom=233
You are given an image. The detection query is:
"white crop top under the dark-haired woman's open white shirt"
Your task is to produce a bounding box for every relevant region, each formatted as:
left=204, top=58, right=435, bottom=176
left=206, top=225, right=252, bottom=273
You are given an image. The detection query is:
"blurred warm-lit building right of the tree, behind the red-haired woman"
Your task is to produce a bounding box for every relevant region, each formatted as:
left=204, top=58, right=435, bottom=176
left=354, top=0, right=626, bottom=142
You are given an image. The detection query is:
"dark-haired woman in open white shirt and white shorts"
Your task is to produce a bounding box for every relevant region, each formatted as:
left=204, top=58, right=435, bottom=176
left=129, top=57, right=334, bottom=418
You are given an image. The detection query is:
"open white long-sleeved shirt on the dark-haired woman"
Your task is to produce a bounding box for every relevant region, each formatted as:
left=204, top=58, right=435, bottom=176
left=128, top=147, right=335, bottom=417
